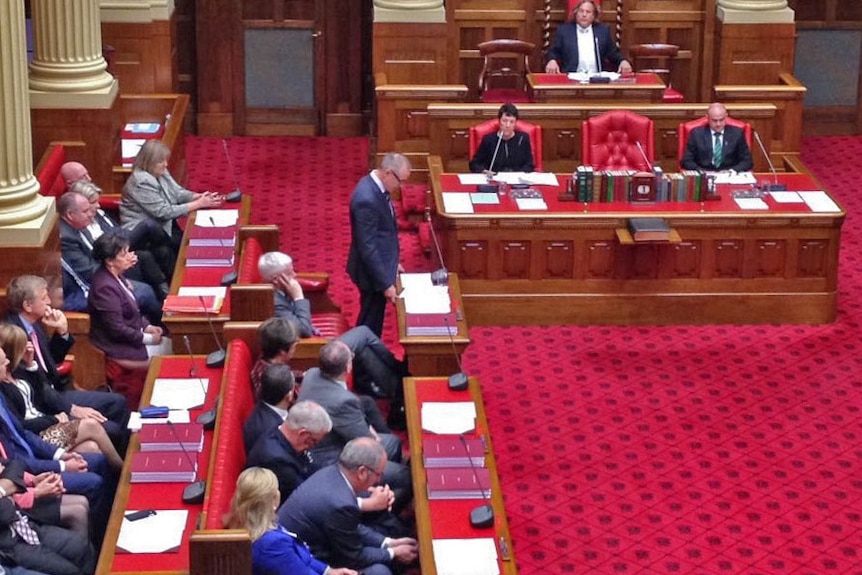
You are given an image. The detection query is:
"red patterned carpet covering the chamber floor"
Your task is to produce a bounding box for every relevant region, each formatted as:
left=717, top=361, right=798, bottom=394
left=188, top=138, right=862, bottom=575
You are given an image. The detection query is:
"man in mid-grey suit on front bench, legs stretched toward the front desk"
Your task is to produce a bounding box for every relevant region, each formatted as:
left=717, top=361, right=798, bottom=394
left=299, top=339, right=413, bottom=512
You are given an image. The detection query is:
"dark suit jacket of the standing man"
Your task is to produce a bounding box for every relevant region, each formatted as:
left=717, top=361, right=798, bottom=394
left=347, top=175, right=400, bottom=292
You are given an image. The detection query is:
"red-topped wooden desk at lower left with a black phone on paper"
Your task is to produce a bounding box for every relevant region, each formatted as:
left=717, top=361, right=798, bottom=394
left=96, top=356, right=222, bottom=575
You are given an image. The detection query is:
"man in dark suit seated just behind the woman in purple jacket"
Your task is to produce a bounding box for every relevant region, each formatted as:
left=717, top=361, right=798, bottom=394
left=57, top=192, right=167, bottom=325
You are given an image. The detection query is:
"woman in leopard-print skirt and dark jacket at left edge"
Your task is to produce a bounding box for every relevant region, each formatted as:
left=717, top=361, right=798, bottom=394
left=0, top=324, right=123, bottom=469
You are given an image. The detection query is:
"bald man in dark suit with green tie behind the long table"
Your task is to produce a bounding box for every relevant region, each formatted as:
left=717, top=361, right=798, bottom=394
left=682, top=102, right=753, bottom=172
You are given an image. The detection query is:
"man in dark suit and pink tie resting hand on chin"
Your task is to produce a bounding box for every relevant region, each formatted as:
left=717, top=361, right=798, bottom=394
left=6, top=275, right=129, bottom=454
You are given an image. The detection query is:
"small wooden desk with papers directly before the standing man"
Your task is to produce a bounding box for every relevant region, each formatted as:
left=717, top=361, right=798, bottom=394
left=395, top=273, right=470, bottom=377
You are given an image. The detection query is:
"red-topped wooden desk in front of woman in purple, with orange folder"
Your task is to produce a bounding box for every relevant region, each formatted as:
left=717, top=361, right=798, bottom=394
left=164, top=200, right=251, bottom=354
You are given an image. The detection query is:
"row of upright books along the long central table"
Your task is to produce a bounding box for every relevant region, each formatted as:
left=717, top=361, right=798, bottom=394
left=571, top=166, right=706, bottom=203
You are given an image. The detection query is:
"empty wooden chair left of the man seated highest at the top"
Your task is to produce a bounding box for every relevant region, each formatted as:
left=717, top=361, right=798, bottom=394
left=479, top=38, right=536, bottom=103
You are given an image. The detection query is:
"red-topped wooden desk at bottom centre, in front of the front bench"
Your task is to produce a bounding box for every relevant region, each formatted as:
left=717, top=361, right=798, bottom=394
left=404, top=377, right=518, bottom=575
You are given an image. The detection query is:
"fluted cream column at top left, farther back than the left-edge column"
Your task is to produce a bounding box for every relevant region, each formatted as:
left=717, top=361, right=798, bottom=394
left=30, top=0, right=117, bottom=109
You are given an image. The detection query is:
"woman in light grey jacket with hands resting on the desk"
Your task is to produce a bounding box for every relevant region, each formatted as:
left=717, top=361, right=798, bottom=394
left=120, top=140, right=224, bottom=253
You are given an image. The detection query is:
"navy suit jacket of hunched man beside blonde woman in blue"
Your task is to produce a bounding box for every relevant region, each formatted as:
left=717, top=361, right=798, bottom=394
left=278, top=465, right=390, bottom=570
